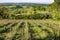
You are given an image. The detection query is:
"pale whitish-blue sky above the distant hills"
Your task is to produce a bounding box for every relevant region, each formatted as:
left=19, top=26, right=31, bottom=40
left=0, top=0, right=54, bottom=4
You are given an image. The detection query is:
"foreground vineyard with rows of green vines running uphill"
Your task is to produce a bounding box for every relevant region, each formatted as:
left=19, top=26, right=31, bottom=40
left=0, top=20, right=60, bottom=40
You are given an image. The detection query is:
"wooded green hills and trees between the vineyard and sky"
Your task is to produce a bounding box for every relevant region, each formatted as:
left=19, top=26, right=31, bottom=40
left=0, top=0, right=60, bottom=20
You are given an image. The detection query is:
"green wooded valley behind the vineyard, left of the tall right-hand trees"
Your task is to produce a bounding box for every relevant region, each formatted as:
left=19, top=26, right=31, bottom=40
left=0, top=4, right=52, bottom=19
